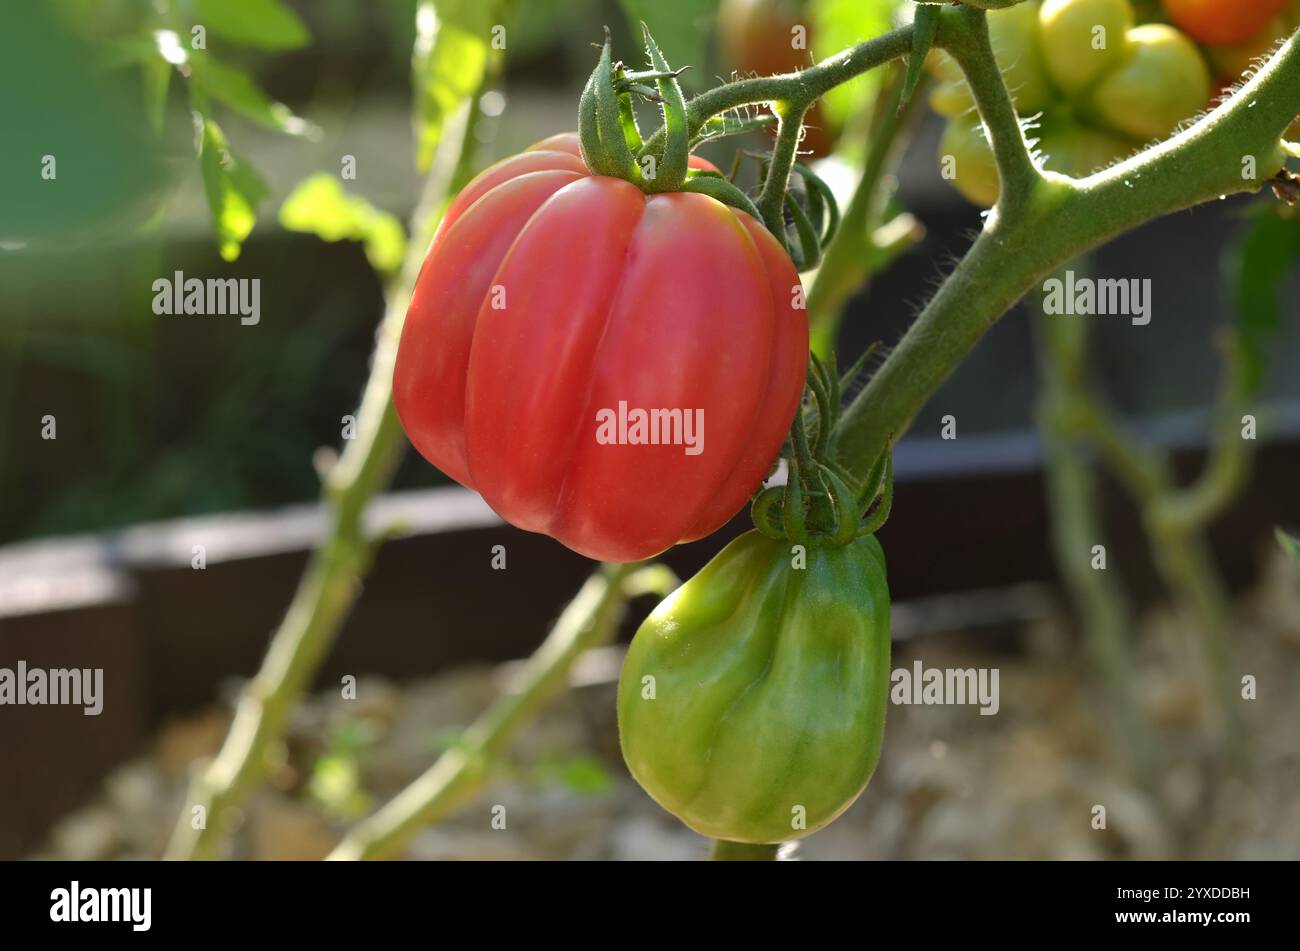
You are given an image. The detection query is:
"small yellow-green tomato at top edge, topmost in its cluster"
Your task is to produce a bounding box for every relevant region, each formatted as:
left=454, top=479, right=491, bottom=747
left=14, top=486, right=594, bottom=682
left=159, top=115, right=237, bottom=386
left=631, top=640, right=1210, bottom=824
left=1039, top=0, right=1134, bottom=96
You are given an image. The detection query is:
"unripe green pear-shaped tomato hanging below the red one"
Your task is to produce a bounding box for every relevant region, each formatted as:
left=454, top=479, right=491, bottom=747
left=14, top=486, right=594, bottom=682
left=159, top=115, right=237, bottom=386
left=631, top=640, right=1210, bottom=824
left=619, top=531, right=889, bottom=843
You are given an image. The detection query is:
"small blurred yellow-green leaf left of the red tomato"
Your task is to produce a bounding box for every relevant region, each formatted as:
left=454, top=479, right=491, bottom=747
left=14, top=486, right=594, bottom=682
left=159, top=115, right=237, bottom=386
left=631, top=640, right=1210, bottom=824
left=280, top=171, right=407, bottom=274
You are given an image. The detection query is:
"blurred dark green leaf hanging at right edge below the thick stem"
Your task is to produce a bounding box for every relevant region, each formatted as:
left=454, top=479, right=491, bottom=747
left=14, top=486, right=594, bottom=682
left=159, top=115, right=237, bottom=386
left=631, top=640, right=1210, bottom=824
left=1226, top=208, right=1300, bottom=395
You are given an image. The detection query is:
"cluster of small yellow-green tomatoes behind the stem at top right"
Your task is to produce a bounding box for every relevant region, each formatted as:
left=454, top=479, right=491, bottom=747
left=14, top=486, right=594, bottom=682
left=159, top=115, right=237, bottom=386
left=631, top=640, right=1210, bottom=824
left=931, top=0, right=1210, bottom=205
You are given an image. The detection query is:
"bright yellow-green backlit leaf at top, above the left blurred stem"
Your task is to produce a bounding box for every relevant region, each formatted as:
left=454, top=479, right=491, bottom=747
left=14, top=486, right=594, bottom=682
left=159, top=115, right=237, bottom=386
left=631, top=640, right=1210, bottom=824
left=411, top=0, right=495, bottom=171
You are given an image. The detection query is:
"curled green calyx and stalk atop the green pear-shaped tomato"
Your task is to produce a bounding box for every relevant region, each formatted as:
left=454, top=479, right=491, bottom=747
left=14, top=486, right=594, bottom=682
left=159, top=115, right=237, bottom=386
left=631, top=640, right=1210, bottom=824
left=750, top=347, right=893, bottom=548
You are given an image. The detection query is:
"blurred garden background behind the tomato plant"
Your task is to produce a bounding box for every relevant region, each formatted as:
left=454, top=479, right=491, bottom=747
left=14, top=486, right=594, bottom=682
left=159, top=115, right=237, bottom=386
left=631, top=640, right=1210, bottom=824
left=0, top=0, right=1300, bottom=859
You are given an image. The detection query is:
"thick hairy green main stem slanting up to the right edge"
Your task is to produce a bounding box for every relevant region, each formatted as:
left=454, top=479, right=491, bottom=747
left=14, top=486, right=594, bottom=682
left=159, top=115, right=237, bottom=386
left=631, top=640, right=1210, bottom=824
left=840, top=31, right=1300, bottom=478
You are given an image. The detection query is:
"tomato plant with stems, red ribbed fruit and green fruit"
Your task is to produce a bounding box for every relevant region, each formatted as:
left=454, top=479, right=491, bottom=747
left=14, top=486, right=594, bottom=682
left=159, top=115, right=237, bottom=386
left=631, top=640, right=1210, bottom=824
left=170, top=0, right=1300, bottom=857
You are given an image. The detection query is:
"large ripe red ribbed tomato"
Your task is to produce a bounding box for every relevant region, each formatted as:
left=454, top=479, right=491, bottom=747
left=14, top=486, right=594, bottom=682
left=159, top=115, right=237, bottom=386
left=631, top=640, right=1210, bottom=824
left=393, top=134, right=807, bottom=561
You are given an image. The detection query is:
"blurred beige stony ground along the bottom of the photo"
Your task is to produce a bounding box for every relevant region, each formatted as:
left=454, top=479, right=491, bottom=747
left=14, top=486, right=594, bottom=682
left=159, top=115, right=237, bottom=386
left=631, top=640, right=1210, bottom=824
left=33, top=551, right=1300, bottom=860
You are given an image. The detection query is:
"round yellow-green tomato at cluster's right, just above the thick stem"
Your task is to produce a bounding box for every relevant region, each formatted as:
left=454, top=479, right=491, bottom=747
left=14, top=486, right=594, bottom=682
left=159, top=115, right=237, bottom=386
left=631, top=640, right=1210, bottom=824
left=1087, top=23, right=1210, bottom=140
